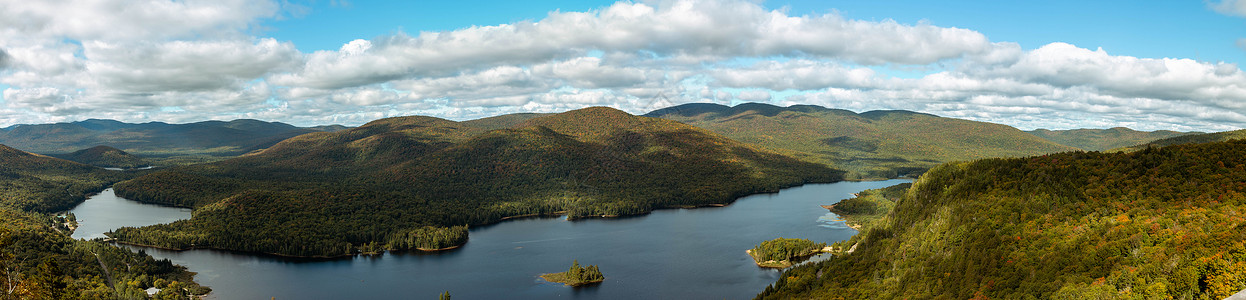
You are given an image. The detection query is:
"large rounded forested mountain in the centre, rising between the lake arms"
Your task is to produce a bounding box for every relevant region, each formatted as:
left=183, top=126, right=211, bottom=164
left=113, top=107, right=842, bottom=256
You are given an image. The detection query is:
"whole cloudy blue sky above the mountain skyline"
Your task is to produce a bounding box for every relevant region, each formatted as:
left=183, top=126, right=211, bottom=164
left=0, top=0, right=1246, bottom=132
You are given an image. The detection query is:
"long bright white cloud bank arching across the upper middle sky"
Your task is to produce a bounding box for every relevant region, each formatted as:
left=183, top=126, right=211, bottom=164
left=278, top=0, right=993, bottom=88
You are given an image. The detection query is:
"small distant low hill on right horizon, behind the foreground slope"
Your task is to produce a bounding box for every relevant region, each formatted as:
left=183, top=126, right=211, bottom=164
left=1027, top=127, right=1199, bottom=151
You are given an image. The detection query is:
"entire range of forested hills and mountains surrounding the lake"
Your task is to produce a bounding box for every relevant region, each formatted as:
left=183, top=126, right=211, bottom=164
left=0, top=103, right=1246, bottom=299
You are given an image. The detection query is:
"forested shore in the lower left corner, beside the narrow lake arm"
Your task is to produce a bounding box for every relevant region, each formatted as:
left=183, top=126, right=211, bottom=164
left=0, top=146, right=207, bottom=299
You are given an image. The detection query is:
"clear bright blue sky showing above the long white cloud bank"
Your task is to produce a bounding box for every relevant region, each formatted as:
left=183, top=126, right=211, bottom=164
left=263, top=0, right=1246, bottom=62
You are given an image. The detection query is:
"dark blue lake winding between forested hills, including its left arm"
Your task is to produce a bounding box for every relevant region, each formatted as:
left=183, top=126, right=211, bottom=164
left=71, top=179, right=910, bottom=299
